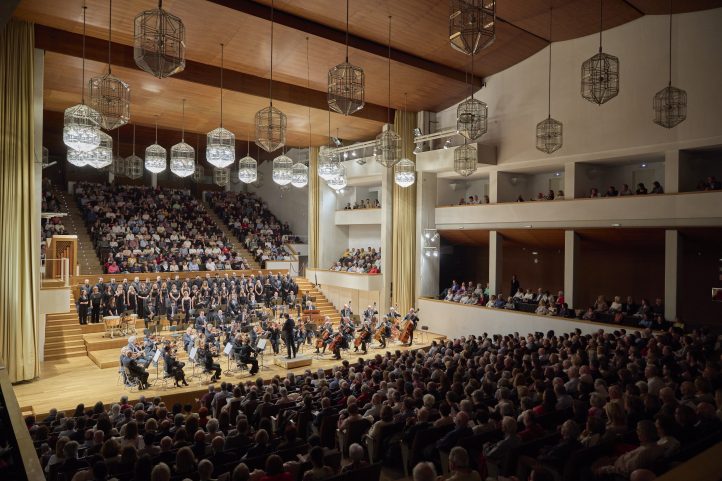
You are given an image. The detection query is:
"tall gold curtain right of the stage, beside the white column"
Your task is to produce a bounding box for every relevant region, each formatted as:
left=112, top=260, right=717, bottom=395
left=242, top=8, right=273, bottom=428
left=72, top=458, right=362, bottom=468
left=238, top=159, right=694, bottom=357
left=391, top=110, right=416, bottom=313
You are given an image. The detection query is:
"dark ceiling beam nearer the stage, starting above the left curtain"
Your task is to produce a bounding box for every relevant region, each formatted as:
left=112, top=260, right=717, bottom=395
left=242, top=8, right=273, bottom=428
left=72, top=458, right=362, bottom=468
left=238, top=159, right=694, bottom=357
left=35, top=24, right=393, bottom=123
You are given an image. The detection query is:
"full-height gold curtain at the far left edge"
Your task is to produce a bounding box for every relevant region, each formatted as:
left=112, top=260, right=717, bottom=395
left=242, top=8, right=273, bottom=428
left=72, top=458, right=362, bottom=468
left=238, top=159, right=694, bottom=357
left=0, top=20, right=40, bottom=382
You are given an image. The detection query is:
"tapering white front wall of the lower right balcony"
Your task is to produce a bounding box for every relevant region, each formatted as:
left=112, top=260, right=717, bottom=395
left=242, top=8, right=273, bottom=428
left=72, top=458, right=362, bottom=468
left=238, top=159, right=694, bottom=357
left=417, top=299, right=630, bottom=338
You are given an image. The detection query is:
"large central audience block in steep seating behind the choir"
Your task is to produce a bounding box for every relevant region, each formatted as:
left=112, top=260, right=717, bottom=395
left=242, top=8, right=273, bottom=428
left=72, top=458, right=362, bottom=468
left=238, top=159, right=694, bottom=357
left=75, top=183, right=248, bottom=274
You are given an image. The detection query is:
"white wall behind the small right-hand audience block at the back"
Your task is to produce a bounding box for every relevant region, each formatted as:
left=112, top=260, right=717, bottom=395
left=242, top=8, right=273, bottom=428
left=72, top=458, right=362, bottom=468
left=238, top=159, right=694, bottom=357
left=243, top=160, right=310, bottom=238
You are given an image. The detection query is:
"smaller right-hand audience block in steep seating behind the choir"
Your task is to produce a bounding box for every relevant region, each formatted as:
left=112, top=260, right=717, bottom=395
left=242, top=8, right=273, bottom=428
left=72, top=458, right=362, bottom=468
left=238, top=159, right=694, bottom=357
left=207, top=192, right=297, bottom=262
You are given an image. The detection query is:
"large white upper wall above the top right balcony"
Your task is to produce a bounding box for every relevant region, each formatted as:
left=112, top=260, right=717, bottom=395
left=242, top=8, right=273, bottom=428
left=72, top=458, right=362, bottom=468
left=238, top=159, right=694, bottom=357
left=430, top=8, right=722, bottom=166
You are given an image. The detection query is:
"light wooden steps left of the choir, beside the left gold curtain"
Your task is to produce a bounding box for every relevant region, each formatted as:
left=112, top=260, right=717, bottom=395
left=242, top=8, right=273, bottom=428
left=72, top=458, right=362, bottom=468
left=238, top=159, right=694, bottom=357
left=45, top=294, right=88, bottom=362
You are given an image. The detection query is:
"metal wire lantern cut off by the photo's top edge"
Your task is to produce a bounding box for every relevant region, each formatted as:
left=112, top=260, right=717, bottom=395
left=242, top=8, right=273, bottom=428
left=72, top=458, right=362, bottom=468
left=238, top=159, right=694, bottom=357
left=449, top=0, right=496, bottom=55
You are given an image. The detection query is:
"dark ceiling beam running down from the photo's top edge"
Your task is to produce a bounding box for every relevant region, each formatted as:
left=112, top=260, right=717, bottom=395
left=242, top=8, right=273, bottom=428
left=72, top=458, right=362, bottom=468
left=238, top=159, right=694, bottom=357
left=205, top=0, right=483, bottom=87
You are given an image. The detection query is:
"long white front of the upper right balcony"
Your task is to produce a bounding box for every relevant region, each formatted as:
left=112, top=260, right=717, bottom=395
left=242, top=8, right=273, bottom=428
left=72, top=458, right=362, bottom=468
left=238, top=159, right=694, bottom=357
left=436, top=191, right=722, bottom=229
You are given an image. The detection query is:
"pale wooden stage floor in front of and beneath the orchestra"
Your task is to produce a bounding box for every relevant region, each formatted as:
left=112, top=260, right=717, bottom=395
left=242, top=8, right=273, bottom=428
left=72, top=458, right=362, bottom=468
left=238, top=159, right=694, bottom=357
left=13, top=330, right=444, bottom=416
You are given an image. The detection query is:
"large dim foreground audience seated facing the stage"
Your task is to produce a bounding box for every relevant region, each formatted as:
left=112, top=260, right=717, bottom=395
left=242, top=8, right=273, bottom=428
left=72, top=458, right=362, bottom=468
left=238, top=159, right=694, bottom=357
left=27, top=329, right=722, bottom=481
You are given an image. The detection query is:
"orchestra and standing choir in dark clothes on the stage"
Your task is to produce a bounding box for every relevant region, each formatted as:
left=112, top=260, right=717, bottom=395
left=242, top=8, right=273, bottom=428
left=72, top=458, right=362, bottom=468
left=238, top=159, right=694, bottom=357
left=107, top=274, right=419, bottom=387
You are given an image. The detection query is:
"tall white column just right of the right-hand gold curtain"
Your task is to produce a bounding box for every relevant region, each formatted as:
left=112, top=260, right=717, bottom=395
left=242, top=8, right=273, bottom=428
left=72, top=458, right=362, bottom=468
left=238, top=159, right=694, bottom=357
left=415, top=172, right=440, bottom=298
